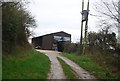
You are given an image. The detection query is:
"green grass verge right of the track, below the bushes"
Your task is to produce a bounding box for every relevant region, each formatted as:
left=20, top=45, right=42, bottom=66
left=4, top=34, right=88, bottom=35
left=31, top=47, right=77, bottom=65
left=63, top=53, right=120, bottom=79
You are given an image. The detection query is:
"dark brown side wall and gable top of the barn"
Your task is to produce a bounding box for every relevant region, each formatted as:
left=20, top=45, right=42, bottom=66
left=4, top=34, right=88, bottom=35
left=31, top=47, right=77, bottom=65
left=32, top=32, right=71, bottom=50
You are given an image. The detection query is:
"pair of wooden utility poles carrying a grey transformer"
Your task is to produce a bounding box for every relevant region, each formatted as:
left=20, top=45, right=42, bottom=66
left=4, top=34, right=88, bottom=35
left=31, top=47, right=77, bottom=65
left=80, top=0, right=89, bottom=54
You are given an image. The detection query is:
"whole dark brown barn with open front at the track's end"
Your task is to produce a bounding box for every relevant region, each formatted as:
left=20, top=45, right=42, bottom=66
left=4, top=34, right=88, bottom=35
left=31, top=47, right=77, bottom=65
left=32, top=31, right=71, bottom=51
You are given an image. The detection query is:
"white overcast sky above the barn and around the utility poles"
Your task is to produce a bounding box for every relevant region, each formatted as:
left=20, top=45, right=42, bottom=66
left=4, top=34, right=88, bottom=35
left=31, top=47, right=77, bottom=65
left=29, top=0, right=102, bottom=42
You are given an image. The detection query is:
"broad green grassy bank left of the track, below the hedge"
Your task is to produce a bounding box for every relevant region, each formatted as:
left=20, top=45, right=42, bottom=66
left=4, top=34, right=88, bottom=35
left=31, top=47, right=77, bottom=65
left=2, top=49, right=50, bottom=79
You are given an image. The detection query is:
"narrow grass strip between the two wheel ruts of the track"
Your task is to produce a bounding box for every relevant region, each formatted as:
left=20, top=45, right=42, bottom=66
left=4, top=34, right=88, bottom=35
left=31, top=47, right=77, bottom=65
left=57, top=57, right=77, bottom=79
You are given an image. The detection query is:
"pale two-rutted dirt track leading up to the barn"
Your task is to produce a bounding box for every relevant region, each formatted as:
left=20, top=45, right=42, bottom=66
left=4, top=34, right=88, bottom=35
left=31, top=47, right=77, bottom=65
left=37, top=50, right=96, bottom=79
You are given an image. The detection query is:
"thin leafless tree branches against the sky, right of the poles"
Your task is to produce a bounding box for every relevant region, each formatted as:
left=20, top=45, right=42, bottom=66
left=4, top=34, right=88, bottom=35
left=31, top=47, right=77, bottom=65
left=91, top=0, right=120, bottom=43
